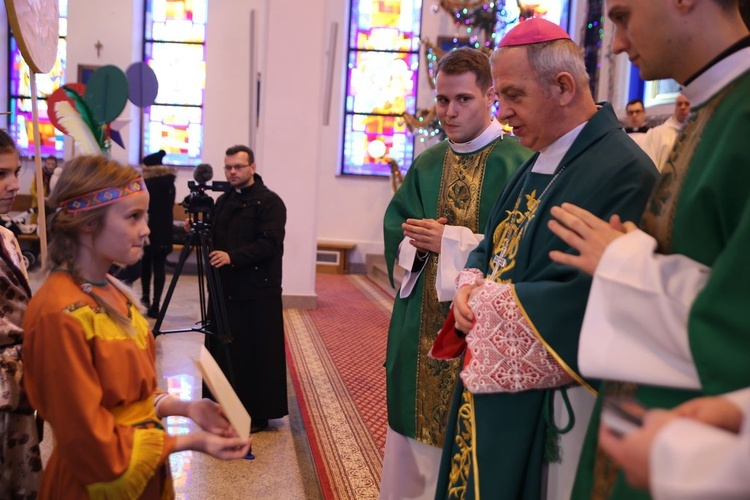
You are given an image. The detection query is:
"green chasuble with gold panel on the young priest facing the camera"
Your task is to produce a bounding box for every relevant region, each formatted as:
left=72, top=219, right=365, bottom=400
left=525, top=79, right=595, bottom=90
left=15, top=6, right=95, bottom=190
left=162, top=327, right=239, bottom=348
left=384, top=135, right=531, bottom=446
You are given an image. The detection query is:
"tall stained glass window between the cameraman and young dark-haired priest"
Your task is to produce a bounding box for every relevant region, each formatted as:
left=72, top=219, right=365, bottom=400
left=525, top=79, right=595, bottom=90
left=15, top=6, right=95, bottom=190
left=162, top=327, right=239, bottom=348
left=341, top=0, right=422, bottom=176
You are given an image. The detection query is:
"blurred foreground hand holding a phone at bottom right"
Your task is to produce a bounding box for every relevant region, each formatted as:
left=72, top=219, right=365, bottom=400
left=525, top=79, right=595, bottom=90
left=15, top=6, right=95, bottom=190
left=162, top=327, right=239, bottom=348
left=599, top=410, right=677, bottom=489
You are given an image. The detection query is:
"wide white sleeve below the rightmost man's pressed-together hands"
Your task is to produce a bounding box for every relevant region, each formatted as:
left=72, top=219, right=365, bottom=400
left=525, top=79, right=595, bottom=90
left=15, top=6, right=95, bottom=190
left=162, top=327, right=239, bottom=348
left=578, top=231, right=710, bottom=389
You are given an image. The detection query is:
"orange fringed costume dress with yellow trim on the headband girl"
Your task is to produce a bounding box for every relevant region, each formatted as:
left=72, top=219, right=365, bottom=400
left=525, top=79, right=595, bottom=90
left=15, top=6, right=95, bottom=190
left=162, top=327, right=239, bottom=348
left=23, top=272, right=175, bottom=499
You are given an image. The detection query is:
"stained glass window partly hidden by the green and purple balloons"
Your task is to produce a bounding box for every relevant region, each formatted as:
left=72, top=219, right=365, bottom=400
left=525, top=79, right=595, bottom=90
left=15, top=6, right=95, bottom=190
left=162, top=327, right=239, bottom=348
left=141, top=0, right=208, bottom=165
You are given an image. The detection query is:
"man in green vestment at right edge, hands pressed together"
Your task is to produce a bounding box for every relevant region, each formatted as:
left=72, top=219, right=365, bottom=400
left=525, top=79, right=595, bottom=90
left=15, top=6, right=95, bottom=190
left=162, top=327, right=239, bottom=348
left=550, top=0, right=750, bottom=499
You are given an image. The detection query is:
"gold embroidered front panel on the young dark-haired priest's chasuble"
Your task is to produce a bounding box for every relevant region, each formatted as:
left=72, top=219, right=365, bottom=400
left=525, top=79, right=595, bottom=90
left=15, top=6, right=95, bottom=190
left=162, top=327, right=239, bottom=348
left=415, top=141, right=497, bottom=447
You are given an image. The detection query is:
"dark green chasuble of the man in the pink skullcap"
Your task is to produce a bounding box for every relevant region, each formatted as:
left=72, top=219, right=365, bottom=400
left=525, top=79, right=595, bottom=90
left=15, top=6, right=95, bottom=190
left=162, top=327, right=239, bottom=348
left=436, top=104, right=658, bottom=500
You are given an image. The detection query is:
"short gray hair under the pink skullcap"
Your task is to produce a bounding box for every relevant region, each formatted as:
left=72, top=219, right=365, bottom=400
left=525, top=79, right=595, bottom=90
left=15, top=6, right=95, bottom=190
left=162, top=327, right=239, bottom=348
left=490, top=39, right=589, bottom=95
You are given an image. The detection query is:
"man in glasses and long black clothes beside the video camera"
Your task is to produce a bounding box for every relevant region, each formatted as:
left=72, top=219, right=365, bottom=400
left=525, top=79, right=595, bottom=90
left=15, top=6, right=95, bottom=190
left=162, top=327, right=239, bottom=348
left=206, top=146, right=287, bottom=432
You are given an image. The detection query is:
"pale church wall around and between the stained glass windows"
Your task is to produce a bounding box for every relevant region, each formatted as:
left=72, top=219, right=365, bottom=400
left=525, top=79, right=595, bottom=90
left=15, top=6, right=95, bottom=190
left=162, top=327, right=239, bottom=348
left=0, top=0, right=656, bottom=302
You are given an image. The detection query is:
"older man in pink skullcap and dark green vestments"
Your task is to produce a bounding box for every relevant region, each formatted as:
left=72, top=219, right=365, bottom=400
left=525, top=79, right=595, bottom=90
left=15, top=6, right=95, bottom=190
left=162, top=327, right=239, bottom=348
left=431, top=19, right=657, bottom=500
